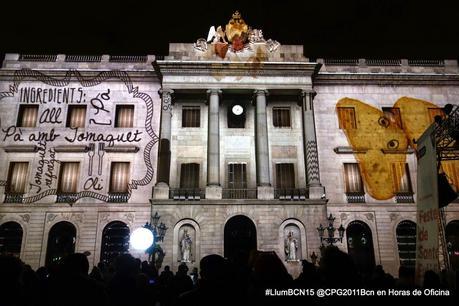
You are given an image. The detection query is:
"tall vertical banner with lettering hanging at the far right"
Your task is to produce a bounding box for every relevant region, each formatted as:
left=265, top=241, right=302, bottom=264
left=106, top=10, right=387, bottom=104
left=416, top=124, right=439, bottom=285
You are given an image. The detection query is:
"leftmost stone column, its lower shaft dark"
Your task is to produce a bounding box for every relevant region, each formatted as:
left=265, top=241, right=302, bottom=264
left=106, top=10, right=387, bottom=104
left=153, top=88, right=174, bottom=199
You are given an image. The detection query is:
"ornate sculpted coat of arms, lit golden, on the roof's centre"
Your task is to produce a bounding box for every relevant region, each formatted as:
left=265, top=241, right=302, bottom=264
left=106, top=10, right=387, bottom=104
left=194, top=11, right=280, bottom=58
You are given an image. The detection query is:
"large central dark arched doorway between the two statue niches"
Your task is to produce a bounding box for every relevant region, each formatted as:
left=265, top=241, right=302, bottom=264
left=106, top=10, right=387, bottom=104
left=224, top=215, right=257, bottom=260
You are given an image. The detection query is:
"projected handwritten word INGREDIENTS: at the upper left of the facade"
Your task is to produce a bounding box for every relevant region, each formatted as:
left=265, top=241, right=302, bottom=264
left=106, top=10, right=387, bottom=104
left=19, top=87, right=86, bottom=104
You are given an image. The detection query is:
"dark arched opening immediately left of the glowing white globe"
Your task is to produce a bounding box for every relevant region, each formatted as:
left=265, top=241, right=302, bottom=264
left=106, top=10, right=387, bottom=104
left=100, top=221, right=130, bottom=265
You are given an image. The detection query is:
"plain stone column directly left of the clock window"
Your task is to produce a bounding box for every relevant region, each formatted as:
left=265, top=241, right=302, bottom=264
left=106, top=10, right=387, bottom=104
left=206, top=89, right=222, bottom=199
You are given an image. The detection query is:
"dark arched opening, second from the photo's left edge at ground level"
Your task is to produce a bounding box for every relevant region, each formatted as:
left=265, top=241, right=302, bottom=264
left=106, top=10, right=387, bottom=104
left=46, top=221, right=76, bottom=266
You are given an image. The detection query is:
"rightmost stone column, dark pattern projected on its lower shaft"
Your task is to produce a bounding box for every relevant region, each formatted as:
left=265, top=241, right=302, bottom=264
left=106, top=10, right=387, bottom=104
left=301, top=90, right=325, bottom=199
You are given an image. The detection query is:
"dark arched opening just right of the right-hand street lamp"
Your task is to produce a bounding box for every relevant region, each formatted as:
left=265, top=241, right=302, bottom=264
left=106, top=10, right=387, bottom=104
left=346, top=221, right=375, bottom=274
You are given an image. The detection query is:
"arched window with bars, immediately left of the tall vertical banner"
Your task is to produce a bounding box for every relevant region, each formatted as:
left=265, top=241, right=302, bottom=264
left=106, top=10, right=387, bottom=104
left=396, top=220, right=416, bottom=268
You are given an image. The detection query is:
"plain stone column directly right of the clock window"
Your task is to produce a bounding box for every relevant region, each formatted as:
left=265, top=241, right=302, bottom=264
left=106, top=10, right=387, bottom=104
left=254, top=89, right=274, bottom=199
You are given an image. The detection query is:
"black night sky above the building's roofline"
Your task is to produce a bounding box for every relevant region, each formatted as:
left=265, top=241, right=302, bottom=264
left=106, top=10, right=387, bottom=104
left=0, top=0, right=459, bottom=58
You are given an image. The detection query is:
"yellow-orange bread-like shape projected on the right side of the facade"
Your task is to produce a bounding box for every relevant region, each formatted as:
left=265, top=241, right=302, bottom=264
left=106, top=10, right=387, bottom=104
left=336, top=97, right=459, bottom=200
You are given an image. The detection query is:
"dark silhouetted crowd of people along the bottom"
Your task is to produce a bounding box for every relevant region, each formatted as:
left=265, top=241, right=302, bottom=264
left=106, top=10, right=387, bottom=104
left=0, top=247, right=458, bottom=306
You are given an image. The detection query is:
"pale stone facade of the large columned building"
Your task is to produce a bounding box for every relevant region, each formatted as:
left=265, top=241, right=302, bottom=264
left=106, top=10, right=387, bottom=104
left=0, top=44, right=459, bottom=276
